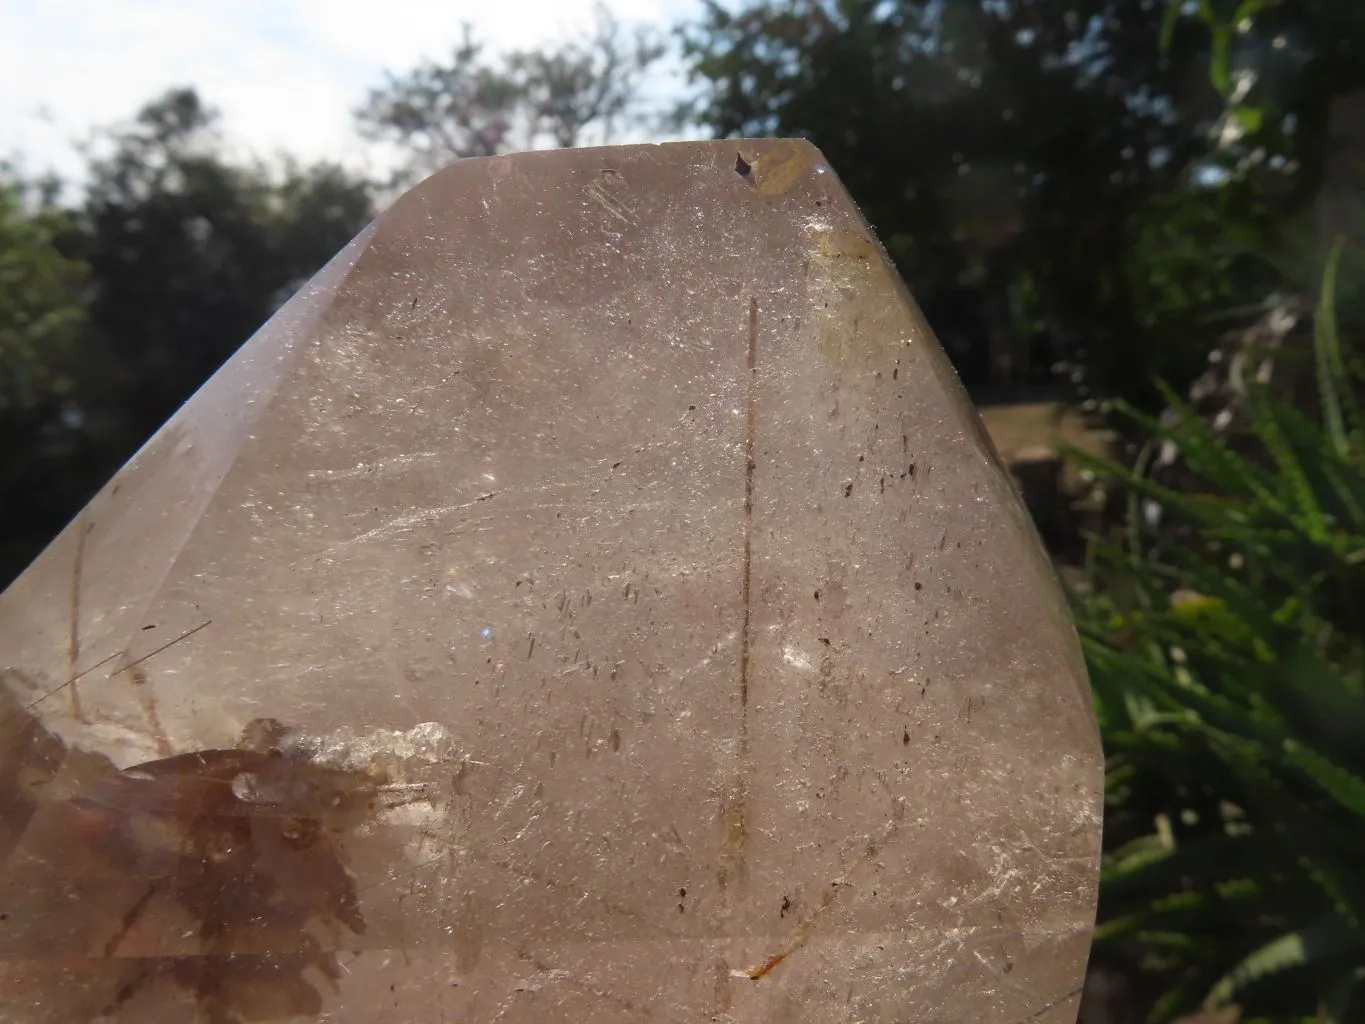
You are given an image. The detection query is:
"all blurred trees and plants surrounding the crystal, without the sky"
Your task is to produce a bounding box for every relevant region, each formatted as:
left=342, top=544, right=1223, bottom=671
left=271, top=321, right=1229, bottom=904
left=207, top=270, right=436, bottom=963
left=0, top=0, right=1365, bottom=1024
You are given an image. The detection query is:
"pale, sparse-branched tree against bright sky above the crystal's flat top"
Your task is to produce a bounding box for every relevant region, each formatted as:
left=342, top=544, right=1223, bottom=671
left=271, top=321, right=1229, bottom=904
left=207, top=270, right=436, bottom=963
left=356, top=4, right=663, bottom=176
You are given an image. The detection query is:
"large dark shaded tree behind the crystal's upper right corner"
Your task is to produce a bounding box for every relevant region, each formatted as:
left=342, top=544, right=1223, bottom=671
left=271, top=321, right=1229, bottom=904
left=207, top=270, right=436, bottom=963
left=681, top=0, right=1294, bottom=407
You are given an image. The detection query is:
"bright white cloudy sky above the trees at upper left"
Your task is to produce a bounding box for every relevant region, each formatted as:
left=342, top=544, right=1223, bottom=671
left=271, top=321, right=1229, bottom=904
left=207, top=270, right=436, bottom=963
left=0, top=0, right=700, bottom=176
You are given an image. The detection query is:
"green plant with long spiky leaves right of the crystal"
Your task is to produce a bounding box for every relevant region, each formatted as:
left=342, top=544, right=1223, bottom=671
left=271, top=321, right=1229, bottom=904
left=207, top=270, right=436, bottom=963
left=1073, top=248, right=1365, bottom=1021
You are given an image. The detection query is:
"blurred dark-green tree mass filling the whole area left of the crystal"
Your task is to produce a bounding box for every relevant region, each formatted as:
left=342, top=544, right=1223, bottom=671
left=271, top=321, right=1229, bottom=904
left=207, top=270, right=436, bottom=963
left=0, top=90, right=371, bottom=579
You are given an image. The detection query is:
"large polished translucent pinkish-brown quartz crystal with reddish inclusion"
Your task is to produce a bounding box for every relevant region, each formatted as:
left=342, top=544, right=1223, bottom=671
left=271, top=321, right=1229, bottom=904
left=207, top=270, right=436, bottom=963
left=0, top=141, right=1102, bottom=1024
